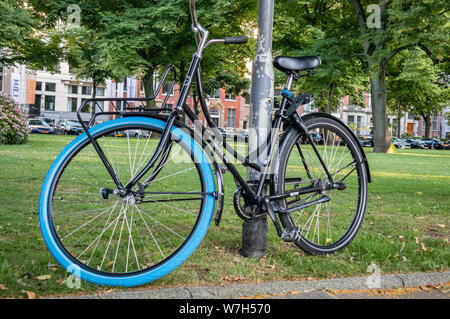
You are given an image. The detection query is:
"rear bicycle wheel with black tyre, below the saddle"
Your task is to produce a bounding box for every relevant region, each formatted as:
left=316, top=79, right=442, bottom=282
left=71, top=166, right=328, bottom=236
left=275, top=117, right=368, bottom=254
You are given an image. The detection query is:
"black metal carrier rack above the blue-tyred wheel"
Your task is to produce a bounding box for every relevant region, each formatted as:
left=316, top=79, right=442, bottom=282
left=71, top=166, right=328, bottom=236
left=77, top=64, right=177, bottom=131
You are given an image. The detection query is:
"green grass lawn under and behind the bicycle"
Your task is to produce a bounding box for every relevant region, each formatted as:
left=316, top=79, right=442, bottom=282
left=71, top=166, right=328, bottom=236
left=0, top=135, right=450, bottom=297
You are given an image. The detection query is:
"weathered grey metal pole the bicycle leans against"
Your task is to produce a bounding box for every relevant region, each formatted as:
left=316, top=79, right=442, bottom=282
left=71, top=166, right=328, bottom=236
left=241, top=0, right=274, bottom=258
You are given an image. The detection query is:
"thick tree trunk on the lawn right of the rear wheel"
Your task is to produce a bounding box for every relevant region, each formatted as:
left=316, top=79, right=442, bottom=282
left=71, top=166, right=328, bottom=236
left=370, top=68, right=391, bottom=153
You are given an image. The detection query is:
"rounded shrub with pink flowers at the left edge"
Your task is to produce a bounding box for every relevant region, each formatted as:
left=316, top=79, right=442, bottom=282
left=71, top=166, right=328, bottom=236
left=0, top=94, right=28, bottom=144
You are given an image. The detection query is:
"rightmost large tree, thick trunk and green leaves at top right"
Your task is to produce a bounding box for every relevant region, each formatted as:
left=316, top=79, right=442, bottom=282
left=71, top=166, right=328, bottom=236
left=351, top=0, right=449, bottom=152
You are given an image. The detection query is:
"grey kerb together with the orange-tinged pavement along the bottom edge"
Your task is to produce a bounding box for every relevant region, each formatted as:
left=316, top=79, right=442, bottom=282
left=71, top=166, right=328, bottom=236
left=67, top=271, right=450, bottom=299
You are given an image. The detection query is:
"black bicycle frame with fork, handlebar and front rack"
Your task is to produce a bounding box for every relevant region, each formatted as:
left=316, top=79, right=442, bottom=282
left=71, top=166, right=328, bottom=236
left=77, top=0, right=332, bottom=212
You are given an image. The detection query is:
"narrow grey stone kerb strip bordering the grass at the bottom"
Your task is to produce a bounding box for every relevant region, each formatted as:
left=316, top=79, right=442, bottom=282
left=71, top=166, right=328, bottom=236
left=66, top=271, right=450, bottom=299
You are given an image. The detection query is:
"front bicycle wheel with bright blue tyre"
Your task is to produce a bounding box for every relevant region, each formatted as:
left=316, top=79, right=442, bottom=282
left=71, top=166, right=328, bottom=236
left=39, top=117, right=215, bottom=286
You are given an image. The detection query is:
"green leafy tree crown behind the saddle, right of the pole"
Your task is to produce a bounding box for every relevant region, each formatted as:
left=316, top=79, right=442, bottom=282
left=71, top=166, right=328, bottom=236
left=274, top=1, right=368, bottom=113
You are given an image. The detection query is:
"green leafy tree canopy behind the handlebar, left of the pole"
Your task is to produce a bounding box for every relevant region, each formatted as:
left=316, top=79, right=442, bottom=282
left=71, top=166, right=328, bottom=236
left=35, top=0, right=255, bottom=106
